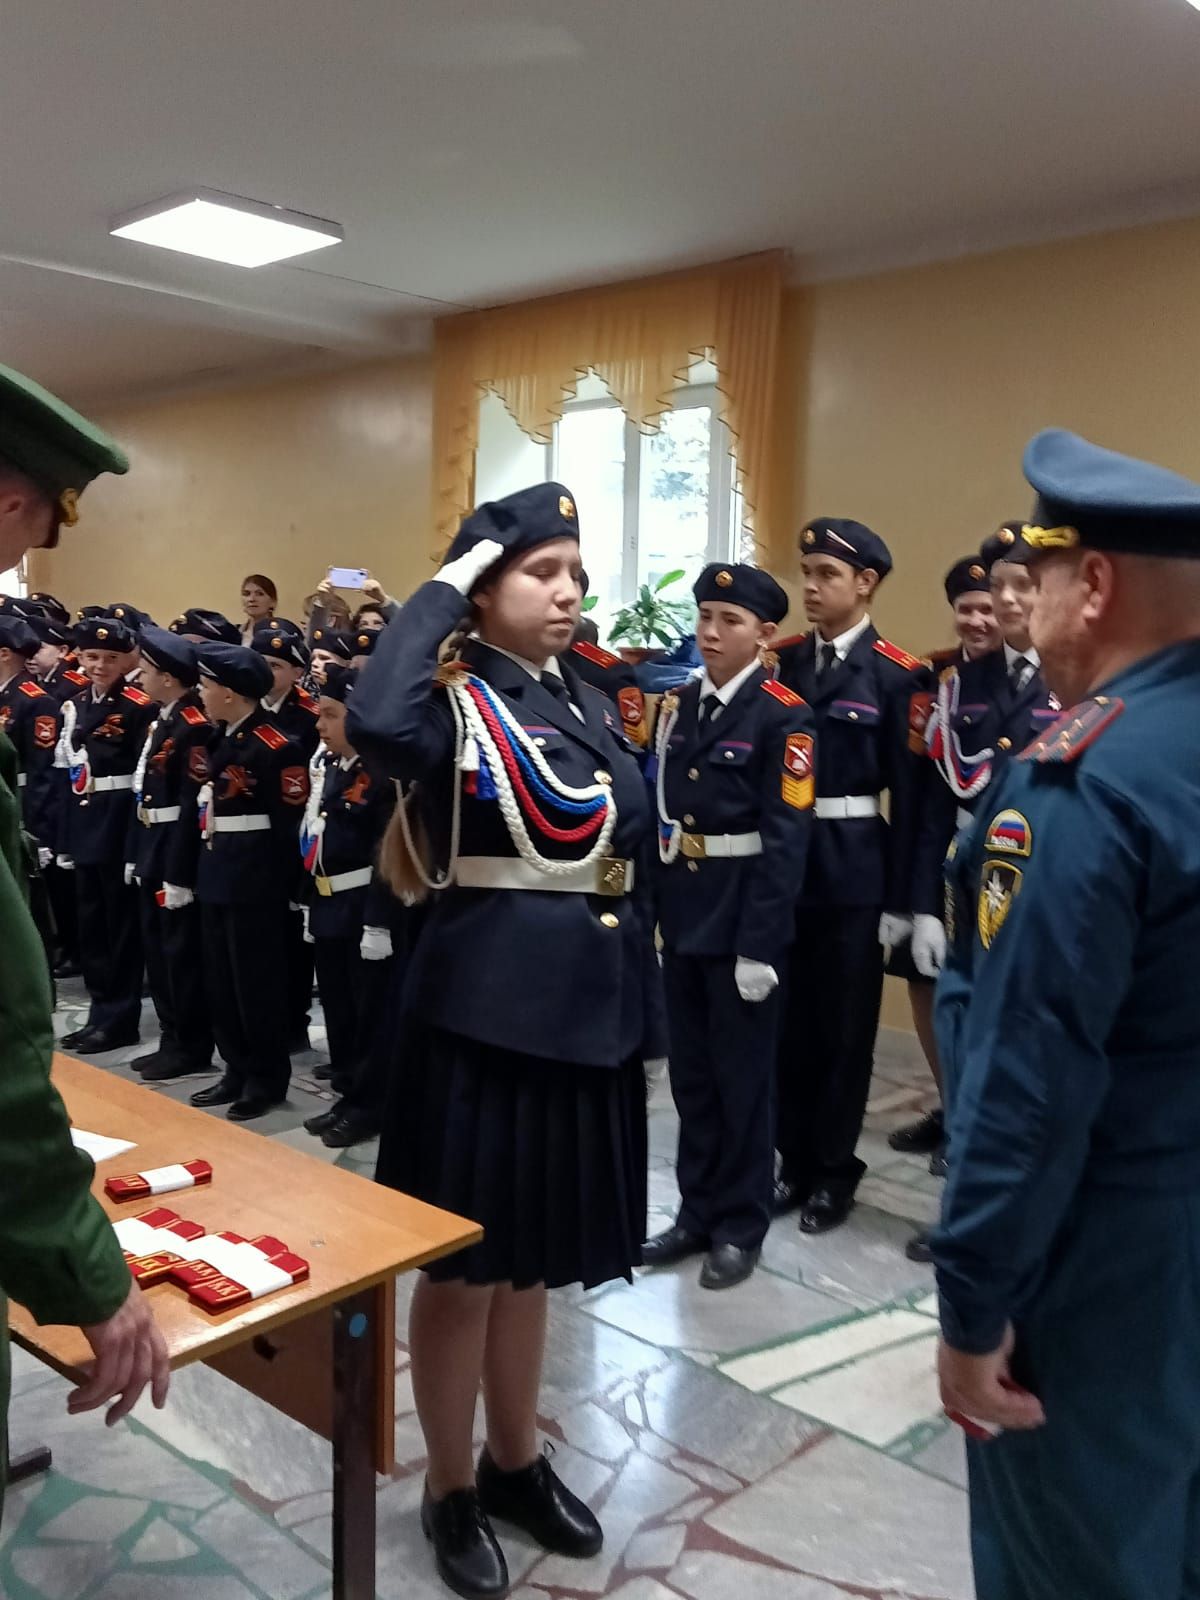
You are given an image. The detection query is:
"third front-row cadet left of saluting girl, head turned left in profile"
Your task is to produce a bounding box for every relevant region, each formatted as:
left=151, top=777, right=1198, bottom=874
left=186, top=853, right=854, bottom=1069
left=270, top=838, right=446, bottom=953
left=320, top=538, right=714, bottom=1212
left=128, top=626, right=214, bottom=1083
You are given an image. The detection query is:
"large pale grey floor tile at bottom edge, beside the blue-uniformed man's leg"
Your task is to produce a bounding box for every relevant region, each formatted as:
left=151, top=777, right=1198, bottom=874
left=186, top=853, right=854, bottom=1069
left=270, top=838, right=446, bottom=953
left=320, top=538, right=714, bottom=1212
left=704, top=1435, right=974, bottom=1600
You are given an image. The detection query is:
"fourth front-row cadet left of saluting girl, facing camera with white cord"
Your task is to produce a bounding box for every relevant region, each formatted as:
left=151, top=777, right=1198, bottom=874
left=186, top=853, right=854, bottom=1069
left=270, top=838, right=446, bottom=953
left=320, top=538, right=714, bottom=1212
left=56, top=613, right=154, bottom=1054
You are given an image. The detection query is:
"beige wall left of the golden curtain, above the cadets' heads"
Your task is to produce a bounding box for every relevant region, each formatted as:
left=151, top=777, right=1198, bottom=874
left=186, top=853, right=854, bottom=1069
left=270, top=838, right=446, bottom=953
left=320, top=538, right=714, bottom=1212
left=30, top=358, right=432, bottom=622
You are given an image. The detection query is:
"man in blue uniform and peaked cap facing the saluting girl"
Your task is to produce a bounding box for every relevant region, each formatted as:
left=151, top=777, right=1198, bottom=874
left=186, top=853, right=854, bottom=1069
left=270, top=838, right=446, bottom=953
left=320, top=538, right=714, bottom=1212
left=933, top=430, right=1200, bottom=1600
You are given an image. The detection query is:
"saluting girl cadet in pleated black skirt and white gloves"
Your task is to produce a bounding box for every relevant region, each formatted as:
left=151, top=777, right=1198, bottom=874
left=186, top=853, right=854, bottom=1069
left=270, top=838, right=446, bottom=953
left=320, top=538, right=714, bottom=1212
left=347, top=483, right=659, bottom=1595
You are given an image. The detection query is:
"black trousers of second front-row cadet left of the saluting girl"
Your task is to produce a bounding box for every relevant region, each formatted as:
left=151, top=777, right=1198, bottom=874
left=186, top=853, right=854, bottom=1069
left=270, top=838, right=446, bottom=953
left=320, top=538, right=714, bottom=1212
left=200, top=901, right=291, bottom=1101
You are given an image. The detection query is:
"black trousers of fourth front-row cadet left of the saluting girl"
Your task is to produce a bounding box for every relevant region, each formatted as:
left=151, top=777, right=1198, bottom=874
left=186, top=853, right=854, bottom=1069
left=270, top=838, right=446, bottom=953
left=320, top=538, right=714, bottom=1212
left=75, top=861, right=142, bottom=1038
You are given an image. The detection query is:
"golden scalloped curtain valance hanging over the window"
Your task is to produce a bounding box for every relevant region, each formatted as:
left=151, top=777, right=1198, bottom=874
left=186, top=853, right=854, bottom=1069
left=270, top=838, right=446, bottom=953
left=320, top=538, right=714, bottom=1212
left=434, top=251, right=782, bottom=554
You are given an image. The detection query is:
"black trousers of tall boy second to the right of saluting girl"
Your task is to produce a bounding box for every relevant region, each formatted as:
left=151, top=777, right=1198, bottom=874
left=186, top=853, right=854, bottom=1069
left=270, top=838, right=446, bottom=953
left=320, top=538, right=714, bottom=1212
left=778, top=906, right=883, bottom=1194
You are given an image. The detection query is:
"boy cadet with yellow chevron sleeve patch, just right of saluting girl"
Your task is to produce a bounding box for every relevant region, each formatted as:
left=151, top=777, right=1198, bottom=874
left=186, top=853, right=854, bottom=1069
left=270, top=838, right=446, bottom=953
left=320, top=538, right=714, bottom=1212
left=642, top=565, right=814, bottom=1290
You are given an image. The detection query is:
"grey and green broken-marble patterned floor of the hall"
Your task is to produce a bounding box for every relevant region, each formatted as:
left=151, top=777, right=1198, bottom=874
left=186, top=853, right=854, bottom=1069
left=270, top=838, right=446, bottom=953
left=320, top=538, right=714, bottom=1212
left=0, top=986, right=973, bottom=1600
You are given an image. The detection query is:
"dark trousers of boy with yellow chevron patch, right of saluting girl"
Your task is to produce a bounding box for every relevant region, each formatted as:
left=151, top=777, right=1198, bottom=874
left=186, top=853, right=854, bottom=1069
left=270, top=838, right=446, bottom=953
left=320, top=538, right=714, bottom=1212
left=662, top=950, right=779, bottom=1250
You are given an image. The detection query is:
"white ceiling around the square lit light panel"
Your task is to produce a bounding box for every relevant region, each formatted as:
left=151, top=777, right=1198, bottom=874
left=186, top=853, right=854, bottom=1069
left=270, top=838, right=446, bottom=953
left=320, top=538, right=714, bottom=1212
left=0, top=0, right=1200, bottom=402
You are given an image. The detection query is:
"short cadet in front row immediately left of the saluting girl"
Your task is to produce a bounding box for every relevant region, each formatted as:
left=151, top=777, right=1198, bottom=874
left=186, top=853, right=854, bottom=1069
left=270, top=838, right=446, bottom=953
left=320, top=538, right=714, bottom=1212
left=299, top=662, right=400, bottom=1147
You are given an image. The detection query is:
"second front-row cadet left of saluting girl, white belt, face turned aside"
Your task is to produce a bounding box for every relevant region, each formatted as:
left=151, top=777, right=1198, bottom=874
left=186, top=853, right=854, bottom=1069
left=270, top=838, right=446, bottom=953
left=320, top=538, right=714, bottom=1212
left=189, top=643, right=309, bottom=1122
